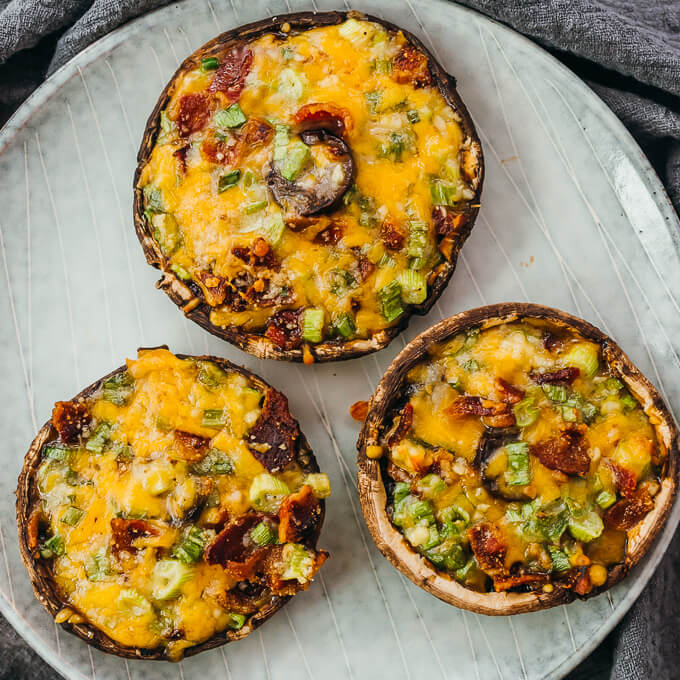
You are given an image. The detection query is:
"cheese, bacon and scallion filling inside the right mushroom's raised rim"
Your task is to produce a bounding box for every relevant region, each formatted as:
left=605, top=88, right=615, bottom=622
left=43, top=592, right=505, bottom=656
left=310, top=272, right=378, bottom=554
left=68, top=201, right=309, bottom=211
left=385, top=321, right=665, bottom=595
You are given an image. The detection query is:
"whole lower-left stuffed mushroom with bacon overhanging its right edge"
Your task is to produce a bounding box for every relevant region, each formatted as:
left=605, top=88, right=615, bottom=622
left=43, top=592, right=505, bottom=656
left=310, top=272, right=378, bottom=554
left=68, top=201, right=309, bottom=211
left=17, top=348, right=330, bottom=661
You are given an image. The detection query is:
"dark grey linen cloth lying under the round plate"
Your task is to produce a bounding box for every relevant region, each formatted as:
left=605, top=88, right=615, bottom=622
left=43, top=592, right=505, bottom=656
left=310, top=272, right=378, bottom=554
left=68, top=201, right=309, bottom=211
left=0, top=0, right=680, bottom=680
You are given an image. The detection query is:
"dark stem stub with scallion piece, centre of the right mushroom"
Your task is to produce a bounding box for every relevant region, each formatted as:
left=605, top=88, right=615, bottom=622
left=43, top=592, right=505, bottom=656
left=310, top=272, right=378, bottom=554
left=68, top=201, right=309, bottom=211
left=474, top=428, right=531, bottom=501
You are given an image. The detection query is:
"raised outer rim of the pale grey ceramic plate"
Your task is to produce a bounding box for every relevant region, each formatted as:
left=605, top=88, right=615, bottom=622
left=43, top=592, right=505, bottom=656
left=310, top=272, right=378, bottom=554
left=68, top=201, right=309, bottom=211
left=0, top=0, right=680, bottom=680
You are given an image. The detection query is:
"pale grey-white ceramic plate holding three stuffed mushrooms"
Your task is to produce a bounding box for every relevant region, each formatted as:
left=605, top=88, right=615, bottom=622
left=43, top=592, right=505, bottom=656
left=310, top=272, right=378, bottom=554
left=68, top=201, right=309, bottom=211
left=0, top=0, right=680, bottom=680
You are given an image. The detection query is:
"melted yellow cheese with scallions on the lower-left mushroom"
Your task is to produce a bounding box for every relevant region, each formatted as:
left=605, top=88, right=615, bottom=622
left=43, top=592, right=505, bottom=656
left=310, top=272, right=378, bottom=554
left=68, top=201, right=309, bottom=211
left=38, top=349, right=328, bottom=658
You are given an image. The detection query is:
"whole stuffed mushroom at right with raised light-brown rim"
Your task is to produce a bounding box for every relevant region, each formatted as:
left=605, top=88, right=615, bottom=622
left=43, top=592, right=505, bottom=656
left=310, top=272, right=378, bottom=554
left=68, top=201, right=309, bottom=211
left=355, top=303, right=678, bottom=615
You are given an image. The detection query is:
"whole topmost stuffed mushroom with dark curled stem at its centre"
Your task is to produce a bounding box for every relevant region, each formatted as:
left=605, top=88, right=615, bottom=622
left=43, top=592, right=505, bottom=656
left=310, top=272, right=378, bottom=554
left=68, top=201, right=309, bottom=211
left=134, top=12, right=483, bottom=363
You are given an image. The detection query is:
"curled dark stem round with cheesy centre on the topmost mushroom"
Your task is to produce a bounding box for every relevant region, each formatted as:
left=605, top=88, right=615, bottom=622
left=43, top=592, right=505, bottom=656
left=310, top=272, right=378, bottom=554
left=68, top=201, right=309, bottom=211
left=267, top=130, right=354, bottom=217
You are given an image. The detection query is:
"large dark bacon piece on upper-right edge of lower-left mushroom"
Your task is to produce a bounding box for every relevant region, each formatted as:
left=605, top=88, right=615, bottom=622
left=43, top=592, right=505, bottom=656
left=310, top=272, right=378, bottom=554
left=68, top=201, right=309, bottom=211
left=247, top=388, right=300, bottom=472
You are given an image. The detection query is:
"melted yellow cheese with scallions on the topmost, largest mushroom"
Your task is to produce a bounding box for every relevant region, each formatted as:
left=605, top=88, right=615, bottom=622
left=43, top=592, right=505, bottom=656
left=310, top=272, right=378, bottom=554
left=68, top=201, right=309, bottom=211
left=139, top=19, right=475, bottom=343
